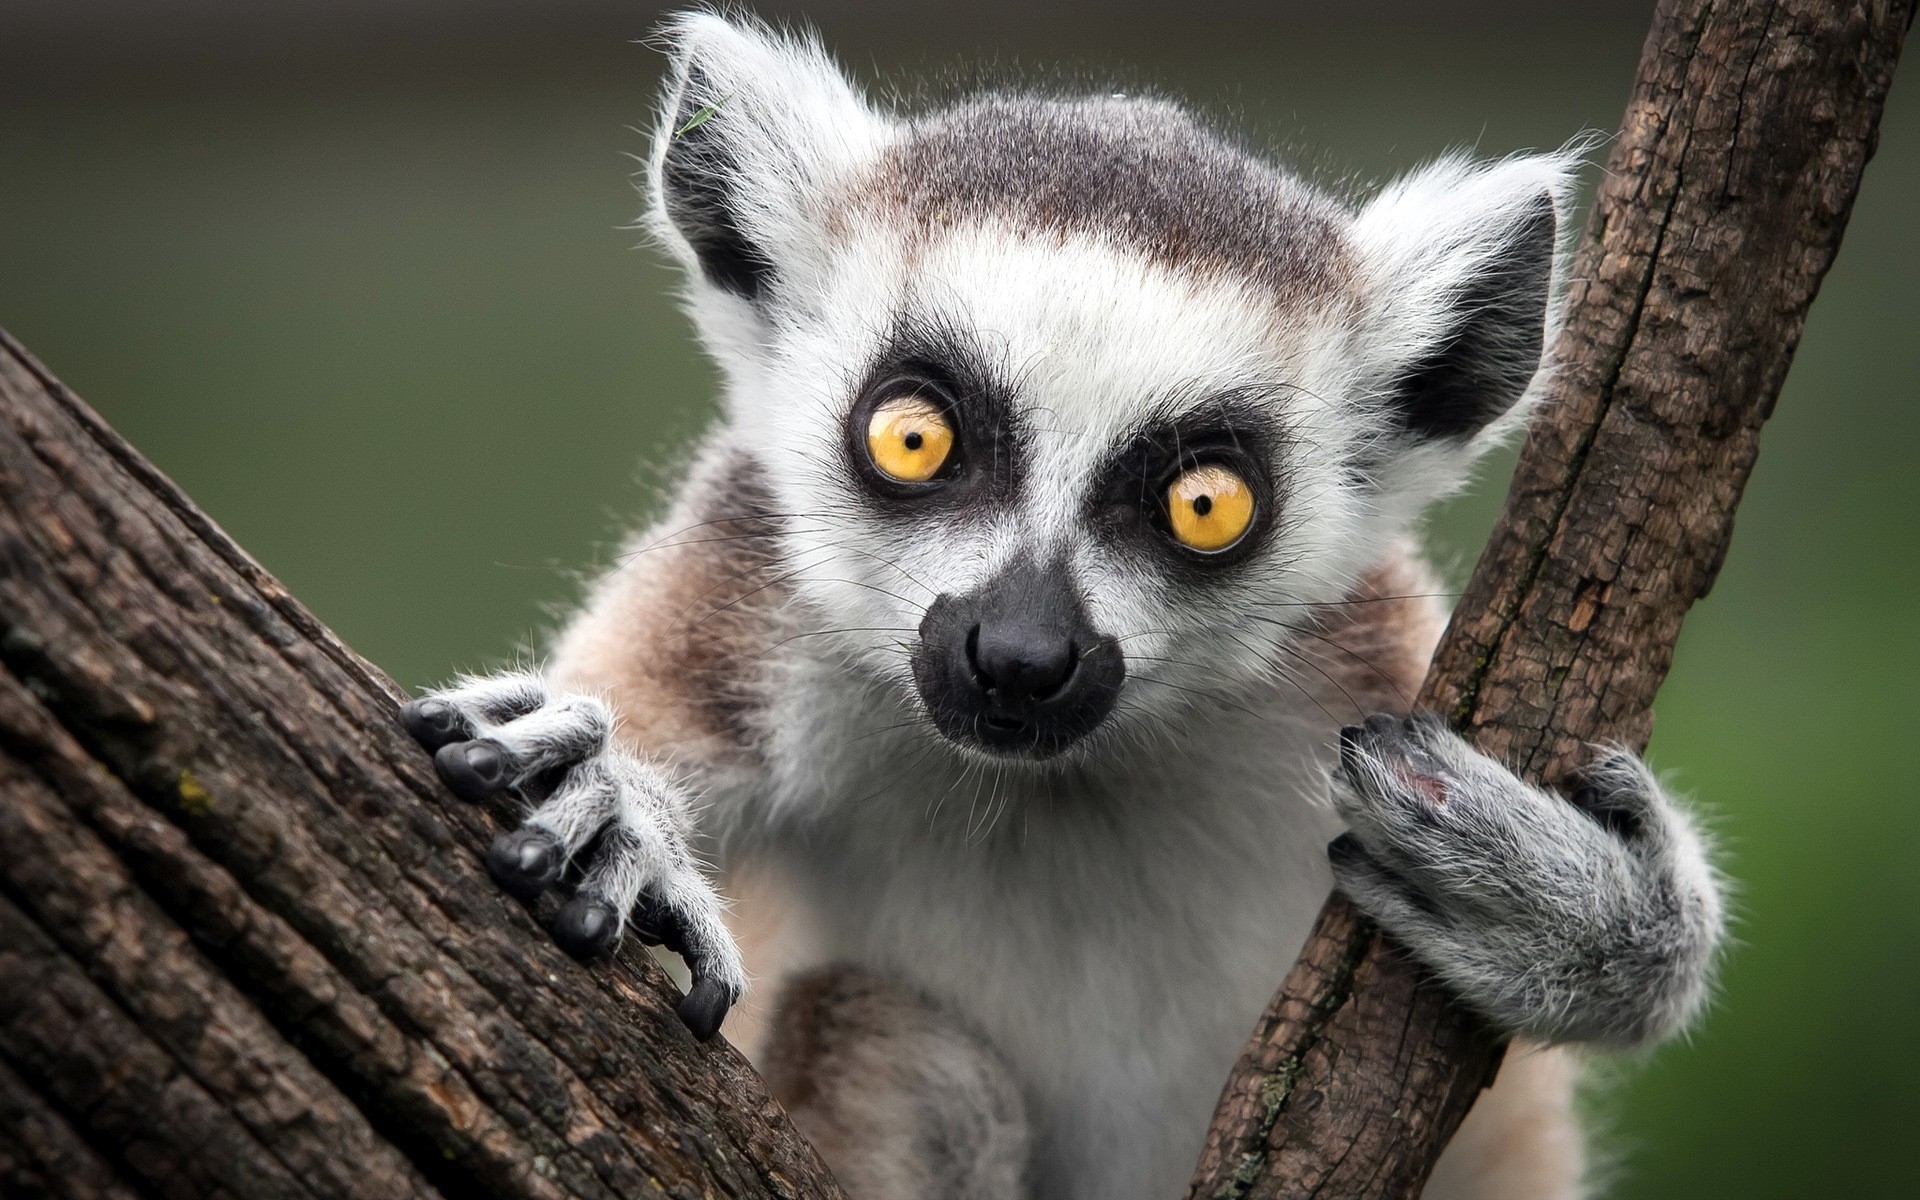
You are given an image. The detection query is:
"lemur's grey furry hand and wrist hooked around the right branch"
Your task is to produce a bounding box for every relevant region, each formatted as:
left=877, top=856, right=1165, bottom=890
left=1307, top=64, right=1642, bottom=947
left=1329, top=714, right=1722, bottom=1044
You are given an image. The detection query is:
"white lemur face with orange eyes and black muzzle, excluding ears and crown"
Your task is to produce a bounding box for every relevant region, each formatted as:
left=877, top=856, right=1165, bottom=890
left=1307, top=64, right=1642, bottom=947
left=794, top=224, right=1342, bottom=756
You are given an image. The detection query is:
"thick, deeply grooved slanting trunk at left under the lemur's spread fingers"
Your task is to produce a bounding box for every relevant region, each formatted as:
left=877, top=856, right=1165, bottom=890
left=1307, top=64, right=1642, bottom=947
left=0, top=322, right=841, bottom=1200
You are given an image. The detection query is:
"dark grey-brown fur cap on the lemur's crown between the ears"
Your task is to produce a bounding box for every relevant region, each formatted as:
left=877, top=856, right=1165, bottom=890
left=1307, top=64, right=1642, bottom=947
left=868, top=96, right=1350, bottom=298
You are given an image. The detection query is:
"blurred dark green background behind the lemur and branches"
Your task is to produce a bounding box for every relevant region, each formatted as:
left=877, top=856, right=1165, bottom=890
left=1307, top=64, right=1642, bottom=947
left=0, top=0, right=1920, bottom=1198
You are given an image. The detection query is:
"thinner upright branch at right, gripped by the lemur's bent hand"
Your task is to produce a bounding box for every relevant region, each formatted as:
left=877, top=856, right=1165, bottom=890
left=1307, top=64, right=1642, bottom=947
left=1188, top=0, right=1914, bottom=1200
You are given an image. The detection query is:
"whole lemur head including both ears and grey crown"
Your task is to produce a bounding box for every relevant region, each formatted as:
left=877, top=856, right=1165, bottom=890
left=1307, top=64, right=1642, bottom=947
left=651, top=15, right=1574, bottom=758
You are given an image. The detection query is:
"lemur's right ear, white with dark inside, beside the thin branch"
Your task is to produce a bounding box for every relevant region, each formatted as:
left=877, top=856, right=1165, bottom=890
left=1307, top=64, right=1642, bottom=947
left=1354, top=152, right=1578, bottom=447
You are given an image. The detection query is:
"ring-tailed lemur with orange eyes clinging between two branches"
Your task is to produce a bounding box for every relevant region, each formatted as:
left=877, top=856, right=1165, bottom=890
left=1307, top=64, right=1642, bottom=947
left=403, top=13, right=1722, bottom=1200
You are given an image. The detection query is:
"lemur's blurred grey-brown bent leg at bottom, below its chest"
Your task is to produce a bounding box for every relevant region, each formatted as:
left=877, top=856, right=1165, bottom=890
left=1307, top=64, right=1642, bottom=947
left=762, top=966, right=1029, bottom=1200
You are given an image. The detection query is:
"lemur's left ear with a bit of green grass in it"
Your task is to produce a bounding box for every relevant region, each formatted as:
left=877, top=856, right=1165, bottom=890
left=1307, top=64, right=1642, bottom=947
left=649, top=13, right=885, bottom=301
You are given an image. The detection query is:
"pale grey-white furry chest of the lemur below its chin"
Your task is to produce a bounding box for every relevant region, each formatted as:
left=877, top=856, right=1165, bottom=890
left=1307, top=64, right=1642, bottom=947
left=752, top=710, right=1338, bottom=1196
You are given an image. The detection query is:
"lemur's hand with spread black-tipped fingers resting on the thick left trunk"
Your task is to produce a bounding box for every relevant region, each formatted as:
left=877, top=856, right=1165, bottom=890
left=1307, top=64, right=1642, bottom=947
left=399, top=672, right=747, bottom=1041
